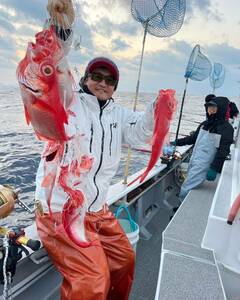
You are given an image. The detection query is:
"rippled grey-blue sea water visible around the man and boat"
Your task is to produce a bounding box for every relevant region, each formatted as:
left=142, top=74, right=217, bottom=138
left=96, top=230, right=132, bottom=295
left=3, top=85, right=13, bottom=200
left=0, top=85, right=205, bottom=227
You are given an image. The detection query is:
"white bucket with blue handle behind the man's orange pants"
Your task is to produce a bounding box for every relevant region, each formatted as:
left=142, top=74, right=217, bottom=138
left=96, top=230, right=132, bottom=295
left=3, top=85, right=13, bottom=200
left=115, top=205, right=139, bottom=252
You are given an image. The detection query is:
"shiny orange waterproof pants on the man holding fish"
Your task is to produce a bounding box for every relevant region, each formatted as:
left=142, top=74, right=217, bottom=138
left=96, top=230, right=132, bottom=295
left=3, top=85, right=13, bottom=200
left=36, top=209, right=135, bottom=300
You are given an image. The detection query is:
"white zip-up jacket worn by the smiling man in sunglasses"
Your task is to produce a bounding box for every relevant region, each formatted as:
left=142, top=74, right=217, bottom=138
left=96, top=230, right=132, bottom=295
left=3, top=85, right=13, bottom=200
left=35, top=93, right=154, bottom=212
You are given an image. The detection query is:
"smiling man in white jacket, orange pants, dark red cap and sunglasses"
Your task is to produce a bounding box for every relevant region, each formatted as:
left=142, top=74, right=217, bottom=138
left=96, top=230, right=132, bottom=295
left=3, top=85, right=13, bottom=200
left=36, top=0, right=154, bottom=300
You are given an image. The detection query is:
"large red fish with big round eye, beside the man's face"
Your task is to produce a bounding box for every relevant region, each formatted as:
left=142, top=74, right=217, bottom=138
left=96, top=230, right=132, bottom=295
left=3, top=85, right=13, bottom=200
left=17, top=27, right=72, bottom=142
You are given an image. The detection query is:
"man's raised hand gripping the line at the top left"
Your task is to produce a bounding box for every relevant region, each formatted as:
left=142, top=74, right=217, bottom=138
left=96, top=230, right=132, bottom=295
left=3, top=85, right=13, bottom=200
left=47, top=0, right=75, bottom=29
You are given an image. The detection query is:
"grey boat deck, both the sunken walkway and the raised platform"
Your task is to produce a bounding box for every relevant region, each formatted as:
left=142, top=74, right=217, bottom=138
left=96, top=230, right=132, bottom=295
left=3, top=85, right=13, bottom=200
left=130, top=178, right=225, bottom=300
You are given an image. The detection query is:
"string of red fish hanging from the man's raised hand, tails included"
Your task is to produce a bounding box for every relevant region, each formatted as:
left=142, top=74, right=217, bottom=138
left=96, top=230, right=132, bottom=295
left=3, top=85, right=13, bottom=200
left=17, top=26, right=93, bottom=247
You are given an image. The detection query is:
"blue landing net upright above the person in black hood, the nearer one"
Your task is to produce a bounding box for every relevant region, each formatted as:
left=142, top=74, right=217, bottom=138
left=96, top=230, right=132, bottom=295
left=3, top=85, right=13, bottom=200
left=184, top=45, right=212, bottom=81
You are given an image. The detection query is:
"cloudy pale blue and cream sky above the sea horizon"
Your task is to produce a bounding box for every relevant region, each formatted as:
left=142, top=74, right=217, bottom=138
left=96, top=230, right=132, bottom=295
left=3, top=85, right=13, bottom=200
left=0, top=0, right=240, bottom=97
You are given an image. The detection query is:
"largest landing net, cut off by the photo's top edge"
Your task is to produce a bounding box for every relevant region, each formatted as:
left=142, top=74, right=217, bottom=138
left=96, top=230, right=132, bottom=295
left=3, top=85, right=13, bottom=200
left=131, top=0, right=186, bottom=37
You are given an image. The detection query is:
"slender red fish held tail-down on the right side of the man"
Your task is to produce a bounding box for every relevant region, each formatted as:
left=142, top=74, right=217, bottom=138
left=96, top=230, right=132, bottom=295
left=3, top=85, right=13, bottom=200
left=128, top=89, right=177, bottom=186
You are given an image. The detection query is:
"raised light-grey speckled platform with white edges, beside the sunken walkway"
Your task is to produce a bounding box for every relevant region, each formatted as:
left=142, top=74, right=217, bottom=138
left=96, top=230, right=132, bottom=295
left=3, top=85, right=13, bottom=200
left=155, top=182, right=226, bottom=300
